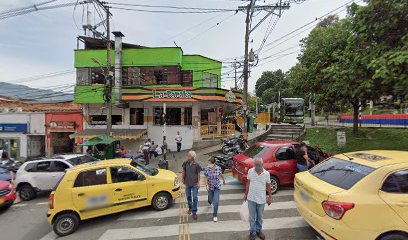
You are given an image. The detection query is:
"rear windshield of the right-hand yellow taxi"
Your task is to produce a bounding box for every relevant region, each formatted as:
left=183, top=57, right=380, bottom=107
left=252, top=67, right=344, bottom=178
left=310, top=158, right=375, bottom=190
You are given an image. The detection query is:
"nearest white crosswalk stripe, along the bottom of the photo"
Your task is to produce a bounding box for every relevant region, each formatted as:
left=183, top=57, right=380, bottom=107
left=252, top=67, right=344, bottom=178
left=99, top=217, right=308, bottom=240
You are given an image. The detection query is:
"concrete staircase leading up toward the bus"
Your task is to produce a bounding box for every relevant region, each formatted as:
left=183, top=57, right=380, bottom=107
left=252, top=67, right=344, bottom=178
left=265, top=124, right=305, bottom=141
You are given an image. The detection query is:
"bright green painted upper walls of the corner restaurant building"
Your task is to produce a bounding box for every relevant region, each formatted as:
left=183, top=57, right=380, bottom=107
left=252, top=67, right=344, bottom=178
left=74, top=47, right=222, bottom=104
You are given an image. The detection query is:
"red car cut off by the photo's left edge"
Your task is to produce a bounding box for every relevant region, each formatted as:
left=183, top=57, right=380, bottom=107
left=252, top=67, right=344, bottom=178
left=0, top=168, right=16, bottom=209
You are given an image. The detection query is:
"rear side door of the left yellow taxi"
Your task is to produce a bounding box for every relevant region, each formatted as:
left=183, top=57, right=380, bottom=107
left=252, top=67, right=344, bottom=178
left=71, top=167, right=113, bottom=219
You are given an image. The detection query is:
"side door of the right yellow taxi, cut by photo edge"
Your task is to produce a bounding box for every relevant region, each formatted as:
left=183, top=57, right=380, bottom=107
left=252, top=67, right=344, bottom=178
left=379, top=168, right=408, bottom=224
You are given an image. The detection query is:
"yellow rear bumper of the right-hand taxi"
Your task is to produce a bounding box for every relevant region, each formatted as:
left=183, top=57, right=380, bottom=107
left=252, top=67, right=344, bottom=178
left=294, top=191, right=375, bottom=240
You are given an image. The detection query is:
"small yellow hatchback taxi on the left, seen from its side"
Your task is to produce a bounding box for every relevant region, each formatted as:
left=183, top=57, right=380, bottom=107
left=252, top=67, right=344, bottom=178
left=47, top=159, right=180, bottom=236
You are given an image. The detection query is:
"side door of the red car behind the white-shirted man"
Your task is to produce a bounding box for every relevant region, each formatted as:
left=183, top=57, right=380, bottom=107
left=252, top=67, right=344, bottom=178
left=274, top=146, right=297, bottom=184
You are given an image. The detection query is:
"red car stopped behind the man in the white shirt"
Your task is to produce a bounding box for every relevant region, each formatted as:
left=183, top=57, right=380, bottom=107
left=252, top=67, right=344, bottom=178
left=232, top=141, right=327, bottom=193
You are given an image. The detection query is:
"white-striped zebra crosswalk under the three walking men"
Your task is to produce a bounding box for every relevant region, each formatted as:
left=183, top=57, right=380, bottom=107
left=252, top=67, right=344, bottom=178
left=39, top=173, right=315, bottom=240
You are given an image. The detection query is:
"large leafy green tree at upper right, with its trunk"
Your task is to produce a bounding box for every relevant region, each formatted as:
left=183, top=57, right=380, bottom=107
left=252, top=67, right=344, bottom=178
left=287, top=0, right=408, bottom=133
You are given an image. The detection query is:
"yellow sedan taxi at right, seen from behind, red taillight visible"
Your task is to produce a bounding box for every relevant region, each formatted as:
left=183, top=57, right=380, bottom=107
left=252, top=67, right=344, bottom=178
left=294, top=150, right=408, bottom=240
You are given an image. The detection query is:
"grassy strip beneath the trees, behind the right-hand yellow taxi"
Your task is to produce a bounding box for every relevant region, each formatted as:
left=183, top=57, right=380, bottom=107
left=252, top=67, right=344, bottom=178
left=304, top=128, right=408, bottom=153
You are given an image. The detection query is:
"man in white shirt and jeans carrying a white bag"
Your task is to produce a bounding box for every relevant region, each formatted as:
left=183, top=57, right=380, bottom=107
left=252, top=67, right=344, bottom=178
left=244, top=158, right=272, bottom=240
